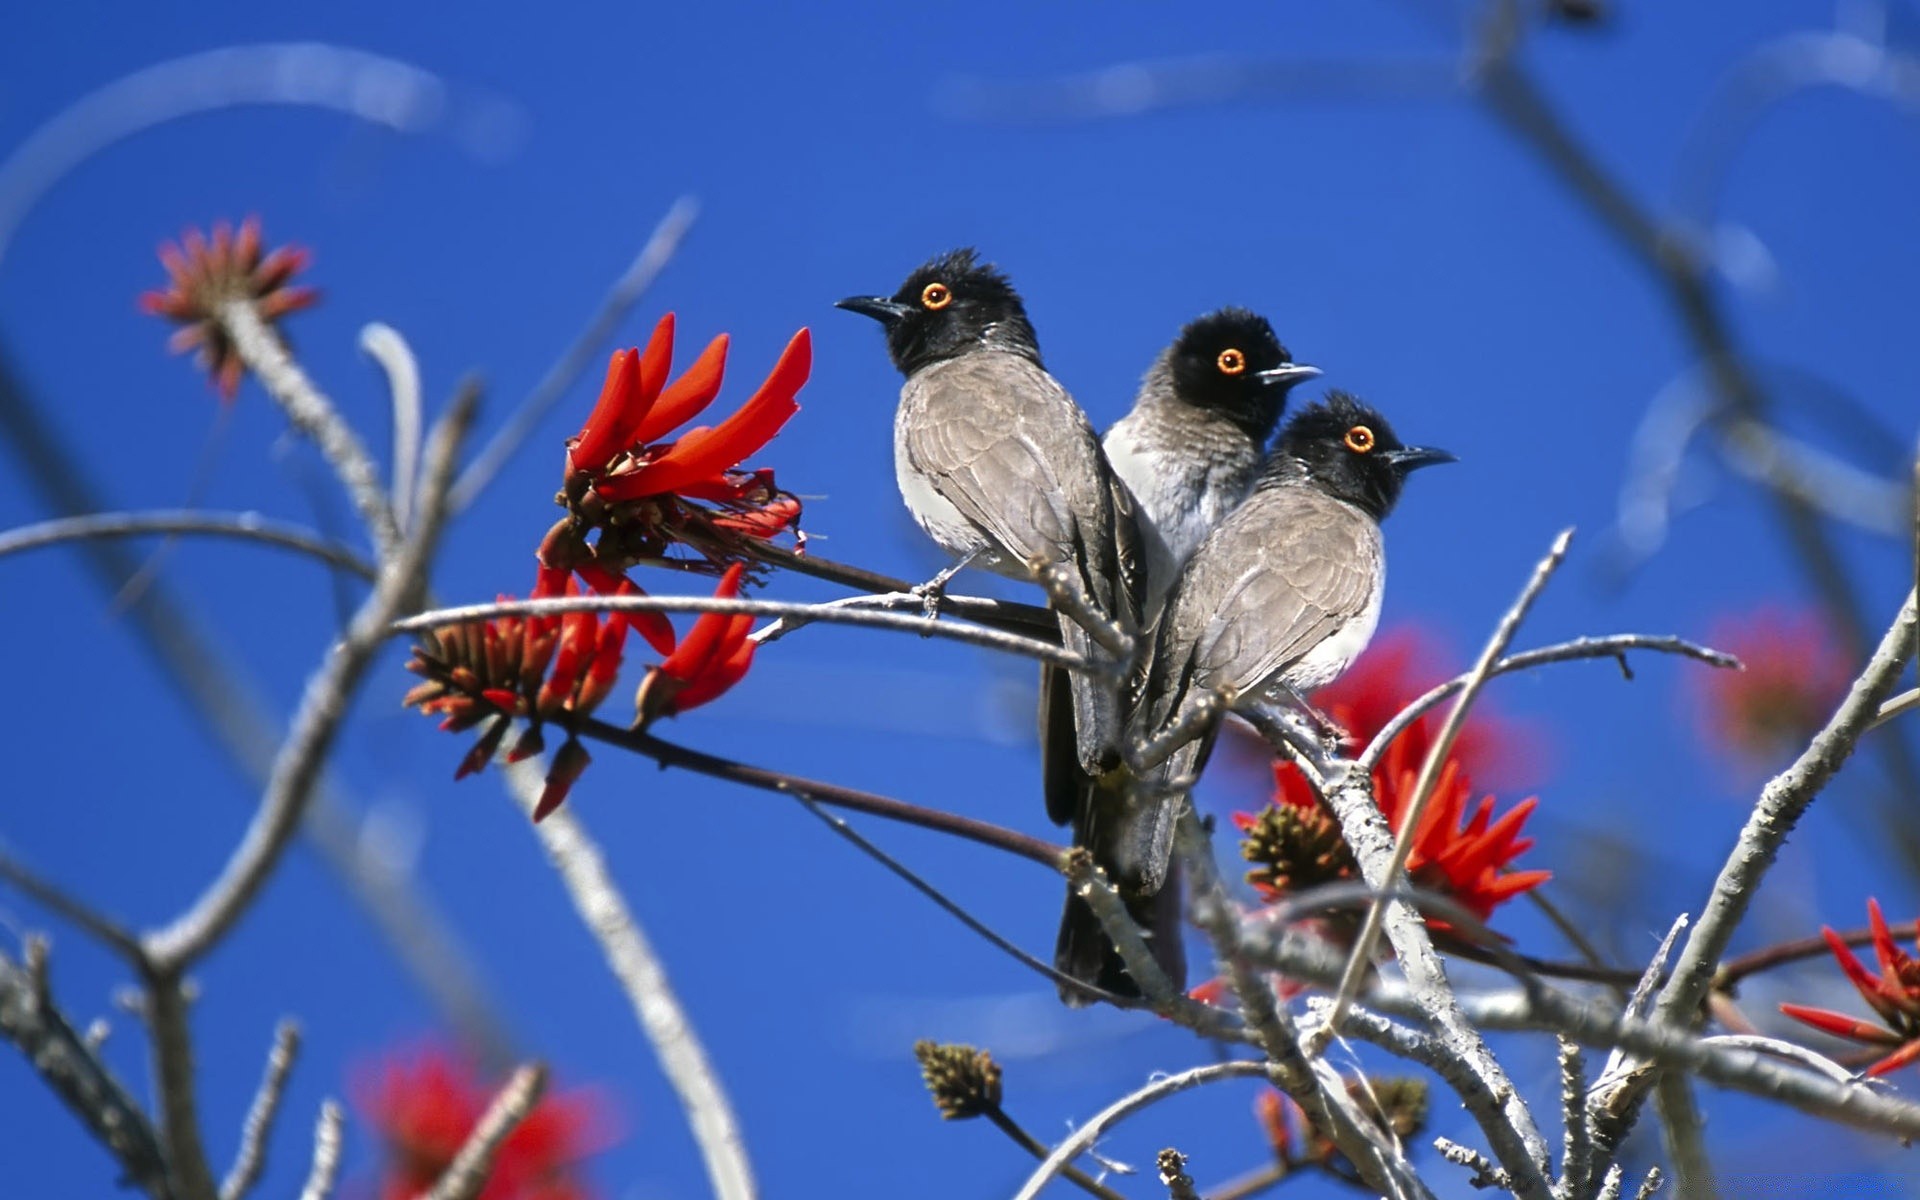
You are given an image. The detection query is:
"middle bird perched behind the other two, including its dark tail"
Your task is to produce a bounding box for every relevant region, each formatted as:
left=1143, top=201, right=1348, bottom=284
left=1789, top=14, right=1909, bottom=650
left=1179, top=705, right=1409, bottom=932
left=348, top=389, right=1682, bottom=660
left=1041, top=307, right=1319, bottom=1004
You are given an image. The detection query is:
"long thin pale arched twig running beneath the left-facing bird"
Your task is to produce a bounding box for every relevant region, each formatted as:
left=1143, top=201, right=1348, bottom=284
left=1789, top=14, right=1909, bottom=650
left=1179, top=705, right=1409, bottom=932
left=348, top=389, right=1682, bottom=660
left=392, top=595, right=1110, bottom=674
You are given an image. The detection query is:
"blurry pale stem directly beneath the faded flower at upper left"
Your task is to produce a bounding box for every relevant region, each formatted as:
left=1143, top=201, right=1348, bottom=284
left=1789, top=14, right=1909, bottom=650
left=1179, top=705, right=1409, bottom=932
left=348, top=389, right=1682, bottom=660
left=217, top=300, right=401, bottom=559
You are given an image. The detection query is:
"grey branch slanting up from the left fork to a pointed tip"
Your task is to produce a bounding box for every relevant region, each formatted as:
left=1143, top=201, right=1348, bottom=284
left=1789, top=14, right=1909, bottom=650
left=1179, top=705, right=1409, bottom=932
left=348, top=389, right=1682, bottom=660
left=144, top=392, right=476, bottom=973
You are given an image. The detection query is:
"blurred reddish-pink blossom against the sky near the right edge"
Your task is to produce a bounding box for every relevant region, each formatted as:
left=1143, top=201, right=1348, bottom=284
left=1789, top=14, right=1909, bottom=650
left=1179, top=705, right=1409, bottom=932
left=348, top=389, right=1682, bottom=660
left=1695, top=607, right=1851, bottom=764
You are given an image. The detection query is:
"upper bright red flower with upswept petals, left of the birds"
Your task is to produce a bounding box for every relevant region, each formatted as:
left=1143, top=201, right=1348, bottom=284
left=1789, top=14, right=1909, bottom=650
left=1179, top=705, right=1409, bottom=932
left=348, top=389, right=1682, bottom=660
left=541, top=313, right=812, bottom=576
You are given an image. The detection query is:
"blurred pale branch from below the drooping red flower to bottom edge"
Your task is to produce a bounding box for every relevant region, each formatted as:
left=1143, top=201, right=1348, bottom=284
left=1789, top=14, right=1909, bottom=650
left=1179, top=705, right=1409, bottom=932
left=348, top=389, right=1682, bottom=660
left=505, top=758, right=756, bottom=1200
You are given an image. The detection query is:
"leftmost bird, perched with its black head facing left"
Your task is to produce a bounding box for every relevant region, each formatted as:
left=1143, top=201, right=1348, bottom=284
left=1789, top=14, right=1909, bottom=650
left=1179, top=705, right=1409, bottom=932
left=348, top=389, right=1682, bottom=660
left=839, top=241, right=1144, bottom=829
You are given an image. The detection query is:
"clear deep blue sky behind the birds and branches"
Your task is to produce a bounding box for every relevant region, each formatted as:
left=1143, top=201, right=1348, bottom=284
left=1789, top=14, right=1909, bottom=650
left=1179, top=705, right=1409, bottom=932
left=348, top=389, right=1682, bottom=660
left=0, top=2, right=1920, bottom=1198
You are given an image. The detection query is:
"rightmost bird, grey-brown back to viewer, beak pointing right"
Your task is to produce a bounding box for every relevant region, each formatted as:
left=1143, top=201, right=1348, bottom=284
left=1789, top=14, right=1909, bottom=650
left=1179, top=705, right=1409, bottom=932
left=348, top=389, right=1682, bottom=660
left=1116, top=392, right=1457, bottom=895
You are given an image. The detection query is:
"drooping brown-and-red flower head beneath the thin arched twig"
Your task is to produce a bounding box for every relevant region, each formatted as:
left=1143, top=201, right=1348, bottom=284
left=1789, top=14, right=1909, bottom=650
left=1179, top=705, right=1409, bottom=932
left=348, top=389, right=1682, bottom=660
left=401, top=568, right=656, bottom=820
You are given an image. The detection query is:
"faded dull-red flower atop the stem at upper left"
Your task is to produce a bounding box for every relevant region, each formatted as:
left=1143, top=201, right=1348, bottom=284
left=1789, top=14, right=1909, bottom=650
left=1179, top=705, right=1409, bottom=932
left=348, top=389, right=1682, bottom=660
left=140, top=217, right=319, bottom=403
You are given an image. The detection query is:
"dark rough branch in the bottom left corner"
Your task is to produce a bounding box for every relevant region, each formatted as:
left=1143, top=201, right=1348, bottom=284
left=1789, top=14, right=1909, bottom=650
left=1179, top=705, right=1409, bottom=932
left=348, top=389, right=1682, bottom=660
left=0, top=941, right=175, bottom=1200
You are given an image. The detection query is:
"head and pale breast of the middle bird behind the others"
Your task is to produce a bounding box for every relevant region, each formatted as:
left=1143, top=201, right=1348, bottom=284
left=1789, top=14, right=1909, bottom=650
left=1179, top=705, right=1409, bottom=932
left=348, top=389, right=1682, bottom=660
left=1104, top=307, right=1319, bottom=612
